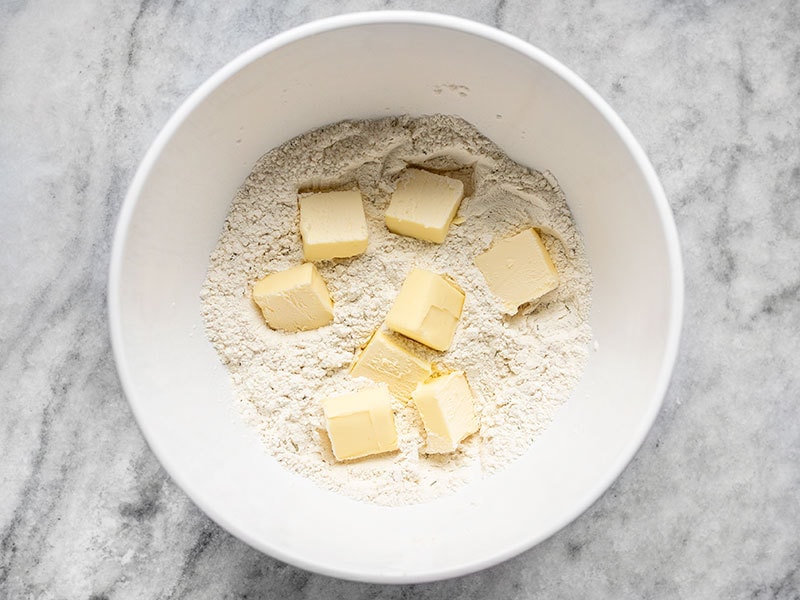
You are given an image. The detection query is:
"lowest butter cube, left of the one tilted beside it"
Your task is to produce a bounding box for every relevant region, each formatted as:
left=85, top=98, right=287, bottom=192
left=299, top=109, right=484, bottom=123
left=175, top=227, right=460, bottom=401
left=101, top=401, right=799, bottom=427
left=322, top=386, right=397, bottom=460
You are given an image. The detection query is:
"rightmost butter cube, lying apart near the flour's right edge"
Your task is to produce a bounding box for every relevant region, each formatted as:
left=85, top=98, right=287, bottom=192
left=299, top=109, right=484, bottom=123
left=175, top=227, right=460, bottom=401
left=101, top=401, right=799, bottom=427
left=475, top=229, right=558, bottom=314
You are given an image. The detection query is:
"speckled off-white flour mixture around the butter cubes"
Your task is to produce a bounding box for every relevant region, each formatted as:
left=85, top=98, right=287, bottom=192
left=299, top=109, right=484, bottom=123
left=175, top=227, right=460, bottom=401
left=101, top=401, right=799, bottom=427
left=201, top=115, right=592, bottom=504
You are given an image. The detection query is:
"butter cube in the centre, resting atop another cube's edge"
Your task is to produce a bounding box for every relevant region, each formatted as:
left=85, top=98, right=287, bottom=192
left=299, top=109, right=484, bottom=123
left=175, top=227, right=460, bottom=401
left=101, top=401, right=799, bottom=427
left=386, top=269, right=464, bottom=350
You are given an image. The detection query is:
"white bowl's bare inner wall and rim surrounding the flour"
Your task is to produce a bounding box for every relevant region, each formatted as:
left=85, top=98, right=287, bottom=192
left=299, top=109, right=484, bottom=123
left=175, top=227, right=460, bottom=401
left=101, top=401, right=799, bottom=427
left=109, top=12, right=683, bottom=582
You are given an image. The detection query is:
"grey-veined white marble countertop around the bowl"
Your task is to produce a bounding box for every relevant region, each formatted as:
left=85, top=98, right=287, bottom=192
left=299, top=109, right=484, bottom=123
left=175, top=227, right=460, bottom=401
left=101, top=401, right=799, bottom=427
left=0, top=0, right=800, bottom=600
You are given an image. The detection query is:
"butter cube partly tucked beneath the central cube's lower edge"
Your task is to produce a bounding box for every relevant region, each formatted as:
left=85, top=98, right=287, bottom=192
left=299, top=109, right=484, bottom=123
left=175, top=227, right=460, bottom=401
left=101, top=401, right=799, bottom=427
left=350, top=331, right=431, bottom=402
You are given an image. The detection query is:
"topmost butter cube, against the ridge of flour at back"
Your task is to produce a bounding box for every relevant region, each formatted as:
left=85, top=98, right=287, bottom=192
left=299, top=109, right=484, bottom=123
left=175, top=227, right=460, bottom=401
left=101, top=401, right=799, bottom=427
left=386, top=169, right=464, bottom=244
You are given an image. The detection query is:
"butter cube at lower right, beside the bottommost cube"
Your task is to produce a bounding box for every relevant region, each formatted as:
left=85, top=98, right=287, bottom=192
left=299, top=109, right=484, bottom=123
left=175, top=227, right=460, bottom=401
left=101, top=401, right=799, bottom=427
left=412, top=371, right=478, bottom=454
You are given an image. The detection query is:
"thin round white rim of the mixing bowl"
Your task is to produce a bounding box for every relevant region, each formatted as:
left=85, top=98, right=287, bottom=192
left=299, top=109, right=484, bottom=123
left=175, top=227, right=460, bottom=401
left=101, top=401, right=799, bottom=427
left=107, top=10, right=684, bottom=583
